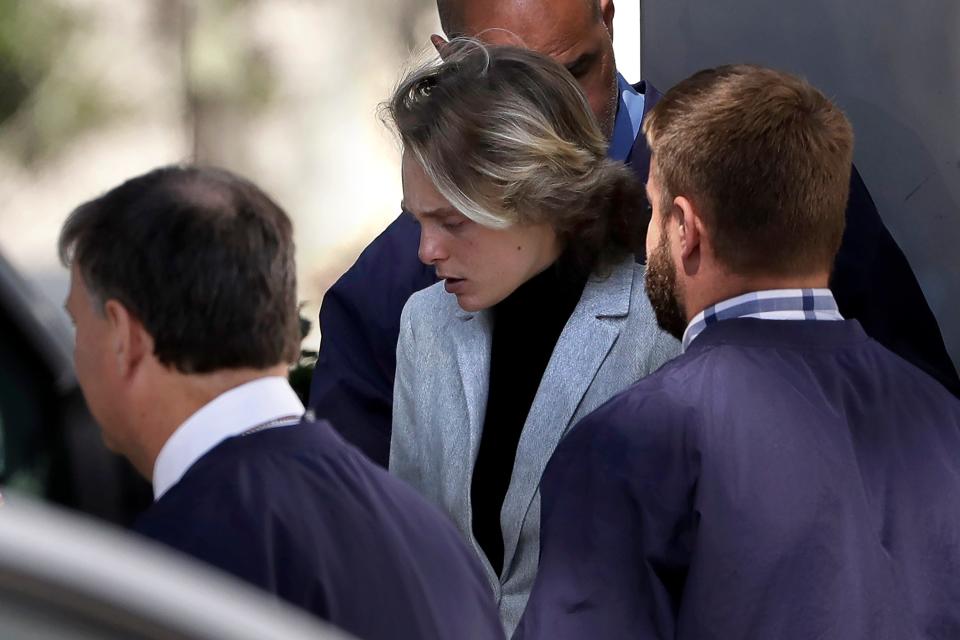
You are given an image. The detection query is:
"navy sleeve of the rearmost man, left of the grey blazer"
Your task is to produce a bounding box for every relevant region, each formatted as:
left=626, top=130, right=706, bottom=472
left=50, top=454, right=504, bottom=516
left=309, top=215, right=436, bottom=466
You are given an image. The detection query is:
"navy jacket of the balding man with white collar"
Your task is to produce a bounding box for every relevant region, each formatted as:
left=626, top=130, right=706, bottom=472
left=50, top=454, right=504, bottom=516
left=136, top=421, right=503, bottom=640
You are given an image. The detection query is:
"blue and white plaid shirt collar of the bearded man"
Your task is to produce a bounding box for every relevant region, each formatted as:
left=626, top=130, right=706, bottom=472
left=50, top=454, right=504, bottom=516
left=683, top=289, right=843, bottom=351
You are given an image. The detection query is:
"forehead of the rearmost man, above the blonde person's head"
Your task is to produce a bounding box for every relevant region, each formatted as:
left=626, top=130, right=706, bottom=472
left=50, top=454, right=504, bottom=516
left=462, top=0, right=595, bottom=56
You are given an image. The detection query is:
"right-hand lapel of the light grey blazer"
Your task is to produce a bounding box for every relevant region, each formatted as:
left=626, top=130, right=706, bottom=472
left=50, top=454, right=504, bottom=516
left=496, top=256, right=634, bottom=571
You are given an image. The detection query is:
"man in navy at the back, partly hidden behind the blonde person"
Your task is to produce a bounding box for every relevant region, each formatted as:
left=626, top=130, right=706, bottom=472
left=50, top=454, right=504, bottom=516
left=309, top=0, right=960, bottom=465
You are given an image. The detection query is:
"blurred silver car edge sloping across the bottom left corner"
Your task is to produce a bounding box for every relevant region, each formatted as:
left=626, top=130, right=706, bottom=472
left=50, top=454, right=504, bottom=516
left=0, top=496, right=349, bottom=640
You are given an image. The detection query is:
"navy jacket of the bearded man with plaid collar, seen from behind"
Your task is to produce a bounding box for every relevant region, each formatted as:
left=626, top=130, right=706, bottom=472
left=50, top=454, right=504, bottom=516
left=514, top=319, right=960, bottom=640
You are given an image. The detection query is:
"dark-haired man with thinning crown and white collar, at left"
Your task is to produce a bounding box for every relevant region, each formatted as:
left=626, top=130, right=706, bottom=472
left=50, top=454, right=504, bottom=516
left=60, top=167, right=503, bottom=640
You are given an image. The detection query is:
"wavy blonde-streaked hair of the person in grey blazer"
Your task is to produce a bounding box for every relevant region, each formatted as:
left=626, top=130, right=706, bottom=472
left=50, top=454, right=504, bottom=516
left=385, top=38, right=646, bottom=268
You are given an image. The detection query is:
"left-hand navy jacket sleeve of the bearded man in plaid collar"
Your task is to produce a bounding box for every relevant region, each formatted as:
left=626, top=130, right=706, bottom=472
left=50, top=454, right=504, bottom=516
left=514, top=396, right=695, bottom=640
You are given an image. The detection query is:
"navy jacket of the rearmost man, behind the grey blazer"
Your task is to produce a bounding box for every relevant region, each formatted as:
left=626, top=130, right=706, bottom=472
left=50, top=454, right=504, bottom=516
left=309, top=82, right=960, bottom=466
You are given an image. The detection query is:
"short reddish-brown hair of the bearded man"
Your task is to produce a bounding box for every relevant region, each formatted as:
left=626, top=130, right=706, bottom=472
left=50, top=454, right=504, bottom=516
left=644, top=65, right=853, bottom=275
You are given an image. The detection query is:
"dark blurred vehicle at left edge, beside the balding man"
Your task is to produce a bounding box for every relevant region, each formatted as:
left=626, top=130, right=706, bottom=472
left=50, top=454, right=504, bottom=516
left=0, top=250, right=152, bottom=525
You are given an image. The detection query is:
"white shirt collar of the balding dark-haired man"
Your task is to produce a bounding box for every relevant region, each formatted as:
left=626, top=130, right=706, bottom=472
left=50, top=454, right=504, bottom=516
left=153, top=376, right=304, bottom=501
